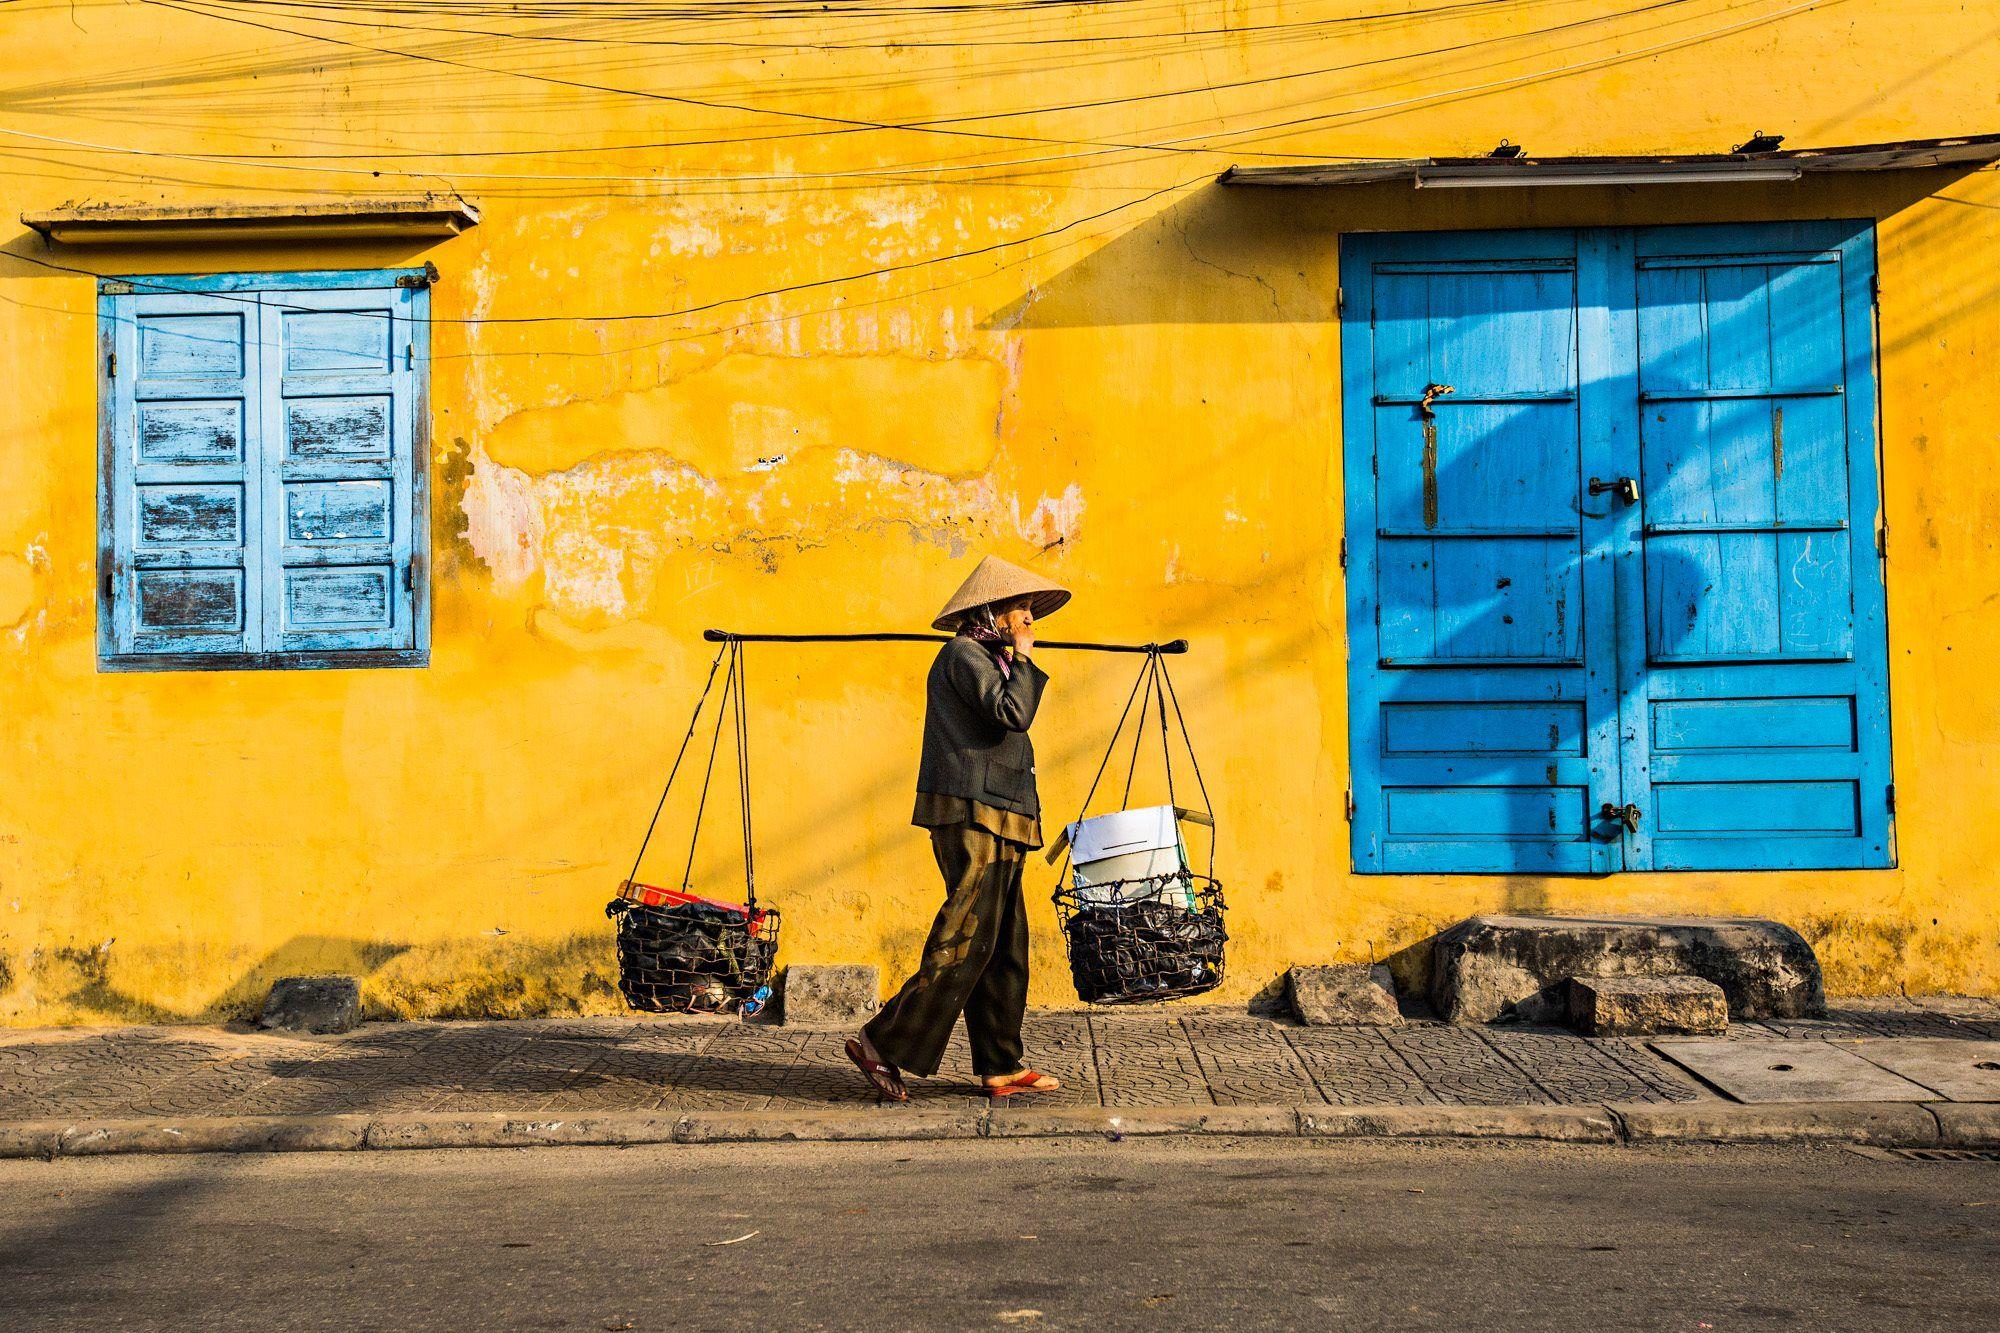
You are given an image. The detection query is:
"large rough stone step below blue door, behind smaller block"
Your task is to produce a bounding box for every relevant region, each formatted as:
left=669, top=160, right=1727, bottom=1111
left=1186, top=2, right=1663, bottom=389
left=1430, top=915, right=1826, bottom=1023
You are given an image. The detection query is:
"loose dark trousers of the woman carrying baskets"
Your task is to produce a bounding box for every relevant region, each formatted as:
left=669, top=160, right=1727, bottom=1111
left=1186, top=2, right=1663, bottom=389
left=866, top=825, right=1028, bottom=1077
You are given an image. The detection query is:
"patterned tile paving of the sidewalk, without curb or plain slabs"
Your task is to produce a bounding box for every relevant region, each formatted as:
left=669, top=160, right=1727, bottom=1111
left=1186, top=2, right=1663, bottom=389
left=0, top=1001, right=2000, bottom=1121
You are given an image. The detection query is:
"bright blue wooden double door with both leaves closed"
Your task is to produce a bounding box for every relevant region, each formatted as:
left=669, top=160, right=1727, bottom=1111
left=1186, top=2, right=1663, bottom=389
left=1342, top=222, right=1894, bottom=873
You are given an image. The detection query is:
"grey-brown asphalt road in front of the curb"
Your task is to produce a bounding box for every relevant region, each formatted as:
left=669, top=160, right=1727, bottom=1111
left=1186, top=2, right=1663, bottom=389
left=0, top=1139, right=2000, bottom=1331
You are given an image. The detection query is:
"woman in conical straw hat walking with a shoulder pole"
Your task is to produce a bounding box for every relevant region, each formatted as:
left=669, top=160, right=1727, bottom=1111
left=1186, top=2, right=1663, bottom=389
left=848, top=556, right=1070, bottom=1101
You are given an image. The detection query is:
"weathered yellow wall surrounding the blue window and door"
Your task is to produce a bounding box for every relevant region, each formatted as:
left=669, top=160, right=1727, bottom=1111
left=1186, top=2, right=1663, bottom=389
left=0, top=0, right=2000, bottom=1023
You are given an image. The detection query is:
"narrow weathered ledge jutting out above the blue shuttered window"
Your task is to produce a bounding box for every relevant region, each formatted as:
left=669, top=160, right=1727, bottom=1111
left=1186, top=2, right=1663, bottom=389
left=20, top=194, right=480, bottom=246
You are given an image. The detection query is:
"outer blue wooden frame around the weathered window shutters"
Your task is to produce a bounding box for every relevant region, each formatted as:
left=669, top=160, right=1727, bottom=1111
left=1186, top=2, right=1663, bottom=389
left=92, top=264, right=438, bottom=673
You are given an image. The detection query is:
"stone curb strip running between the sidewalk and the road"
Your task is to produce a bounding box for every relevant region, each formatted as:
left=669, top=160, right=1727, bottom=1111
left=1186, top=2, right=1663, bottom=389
left=0, top=1101, right=2000, bottom=1161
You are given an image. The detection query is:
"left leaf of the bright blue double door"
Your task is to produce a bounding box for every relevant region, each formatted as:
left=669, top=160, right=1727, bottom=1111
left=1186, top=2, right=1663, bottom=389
left=1344, top=232, right=1618, bottom=873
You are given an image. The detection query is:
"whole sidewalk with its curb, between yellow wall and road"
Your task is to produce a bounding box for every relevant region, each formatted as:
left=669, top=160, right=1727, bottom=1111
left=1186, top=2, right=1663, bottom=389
left=0, top=1001, right=2000, bottom=1157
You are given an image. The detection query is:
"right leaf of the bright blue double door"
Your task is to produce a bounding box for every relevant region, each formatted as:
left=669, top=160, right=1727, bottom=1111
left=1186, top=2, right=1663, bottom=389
left=1620, top=224, right=1892, bottom=869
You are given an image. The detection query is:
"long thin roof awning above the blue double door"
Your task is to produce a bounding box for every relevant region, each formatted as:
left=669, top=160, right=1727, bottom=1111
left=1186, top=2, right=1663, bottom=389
left=1220, top=134, right=2000, bottom=190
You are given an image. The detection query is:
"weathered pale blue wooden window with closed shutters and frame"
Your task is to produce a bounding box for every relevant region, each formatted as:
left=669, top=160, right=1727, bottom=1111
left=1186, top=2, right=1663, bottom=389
left=98, top=272, right=428, bottom=671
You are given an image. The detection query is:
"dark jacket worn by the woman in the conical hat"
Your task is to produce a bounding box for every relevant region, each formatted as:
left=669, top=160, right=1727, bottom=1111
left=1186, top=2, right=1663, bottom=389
left=916, top=634, right=1048, bottom=817
